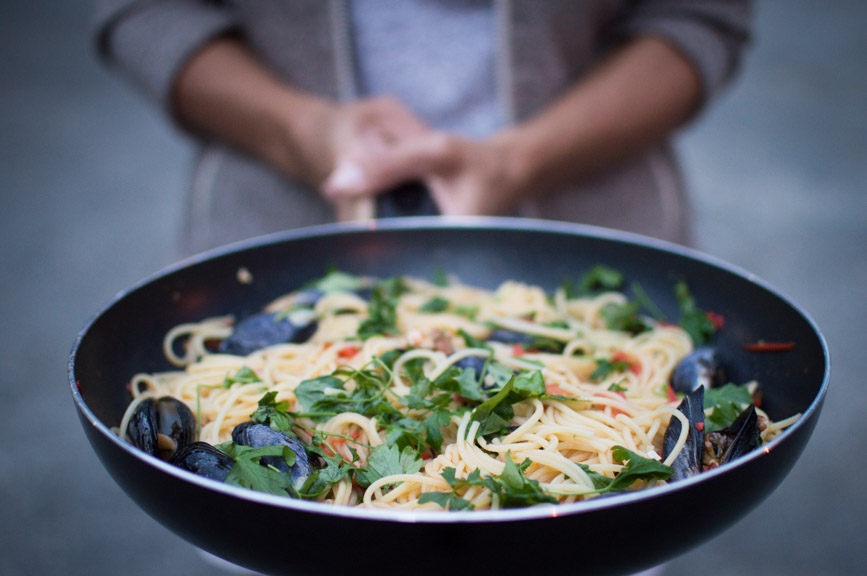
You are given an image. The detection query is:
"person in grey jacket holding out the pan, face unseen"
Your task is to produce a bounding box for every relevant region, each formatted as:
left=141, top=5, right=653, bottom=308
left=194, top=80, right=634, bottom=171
left=95, top=0, right=750, bottom=252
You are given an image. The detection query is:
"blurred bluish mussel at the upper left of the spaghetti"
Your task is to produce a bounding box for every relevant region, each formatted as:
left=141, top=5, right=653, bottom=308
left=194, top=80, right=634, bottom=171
left=218, top=312, right=318, bottom=356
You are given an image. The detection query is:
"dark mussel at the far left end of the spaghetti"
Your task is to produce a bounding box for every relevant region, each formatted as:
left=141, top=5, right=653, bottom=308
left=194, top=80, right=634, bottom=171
left=127, top=396, right=196, bottom=460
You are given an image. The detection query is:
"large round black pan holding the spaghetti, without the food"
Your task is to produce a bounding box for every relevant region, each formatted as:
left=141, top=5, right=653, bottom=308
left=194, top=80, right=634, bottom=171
left=69, top=218, right=830, bottom=574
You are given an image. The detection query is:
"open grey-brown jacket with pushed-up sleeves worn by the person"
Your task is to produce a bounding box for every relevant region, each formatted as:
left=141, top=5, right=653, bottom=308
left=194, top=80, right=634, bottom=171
left=96, top=0, right=750, bottom=251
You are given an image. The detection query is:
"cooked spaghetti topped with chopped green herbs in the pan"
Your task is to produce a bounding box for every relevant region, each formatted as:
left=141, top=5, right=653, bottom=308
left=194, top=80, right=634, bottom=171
left=119, top=273, right=789, bottom=510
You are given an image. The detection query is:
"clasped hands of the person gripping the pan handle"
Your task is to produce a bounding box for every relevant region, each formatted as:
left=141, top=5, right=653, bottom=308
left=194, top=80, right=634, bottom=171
left=321, top=97, right=517, bottom=219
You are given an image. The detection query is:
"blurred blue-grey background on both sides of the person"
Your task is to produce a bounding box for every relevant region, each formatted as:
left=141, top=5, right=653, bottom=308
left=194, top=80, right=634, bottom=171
left=0, top=0, right=867, bottom=576
